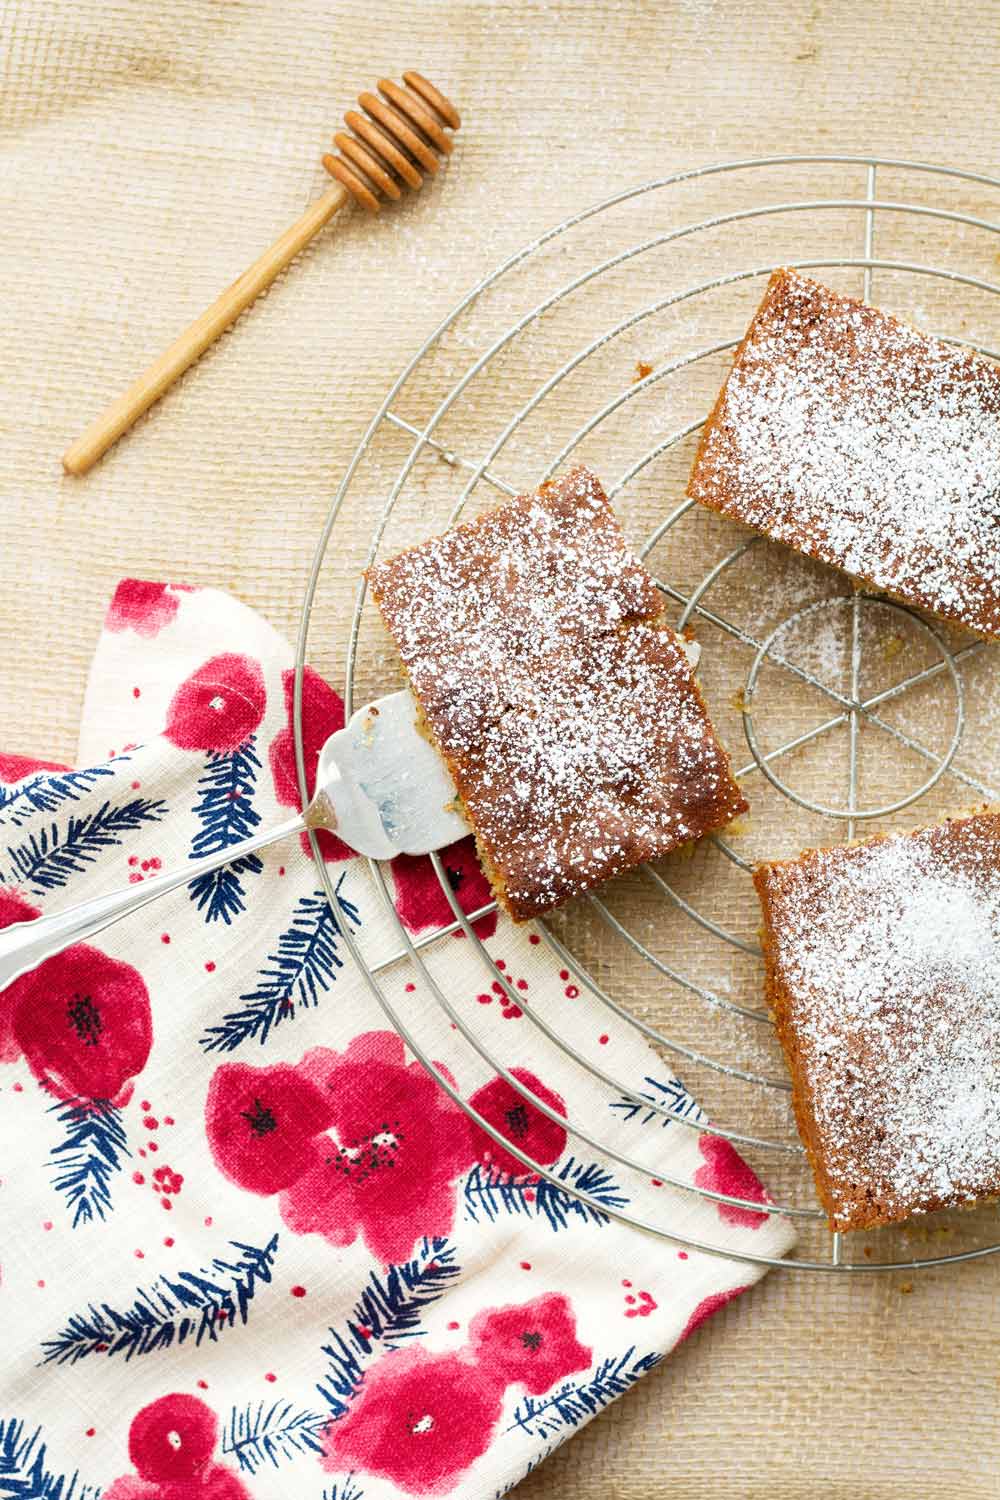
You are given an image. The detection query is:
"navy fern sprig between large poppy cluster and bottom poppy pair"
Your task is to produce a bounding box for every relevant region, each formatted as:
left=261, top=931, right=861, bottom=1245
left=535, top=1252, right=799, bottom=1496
left=316, top=1239, right=462, bottom=1416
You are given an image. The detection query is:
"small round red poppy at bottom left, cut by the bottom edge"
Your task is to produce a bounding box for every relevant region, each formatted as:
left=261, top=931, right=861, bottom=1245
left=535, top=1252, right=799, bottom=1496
left=103, top=1392, right=250, bottom=1500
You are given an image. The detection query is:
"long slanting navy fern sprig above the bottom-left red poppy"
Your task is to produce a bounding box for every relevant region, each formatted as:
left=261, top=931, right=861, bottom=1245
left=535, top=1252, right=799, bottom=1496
left=40, top=1235, right=277, bottom=1368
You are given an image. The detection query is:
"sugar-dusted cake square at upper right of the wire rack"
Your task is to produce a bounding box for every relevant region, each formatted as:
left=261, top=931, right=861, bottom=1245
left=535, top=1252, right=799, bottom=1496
left=688, top=270, right=1000, bottom=636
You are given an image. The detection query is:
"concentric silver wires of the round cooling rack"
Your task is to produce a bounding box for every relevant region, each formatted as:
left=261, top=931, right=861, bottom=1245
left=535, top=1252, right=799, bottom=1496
left=294, top=155, right=1000, bottom=1272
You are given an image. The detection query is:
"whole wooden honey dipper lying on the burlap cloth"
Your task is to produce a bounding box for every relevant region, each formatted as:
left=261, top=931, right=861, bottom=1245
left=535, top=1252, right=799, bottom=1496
left=63, top=72, right=462, bottom=474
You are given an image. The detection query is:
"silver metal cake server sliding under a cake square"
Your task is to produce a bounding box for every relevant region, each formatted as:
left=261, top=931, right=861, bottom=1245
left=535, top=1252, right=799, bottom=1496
left=0, top=641, right=700, bottom=990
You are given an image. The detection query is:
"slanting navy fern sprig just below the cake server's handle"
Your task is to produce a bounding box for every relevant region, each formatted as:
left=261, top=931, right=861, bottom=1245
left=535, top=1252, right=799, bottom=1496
left=199, top=876, right=361, bottom=1052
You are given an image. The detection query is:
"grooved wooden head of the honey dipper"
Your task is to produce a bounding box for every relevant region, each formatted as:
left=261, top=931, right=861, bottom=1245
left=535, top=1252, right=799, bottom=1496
left=322, top=71, right=462, bottom=213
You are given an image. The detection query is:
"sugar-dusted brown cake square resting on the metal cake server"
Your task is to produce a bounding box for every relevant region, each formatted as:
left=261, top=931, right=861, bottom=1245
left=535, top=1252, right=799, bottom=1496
left=369, top=468, right=747, bottom=921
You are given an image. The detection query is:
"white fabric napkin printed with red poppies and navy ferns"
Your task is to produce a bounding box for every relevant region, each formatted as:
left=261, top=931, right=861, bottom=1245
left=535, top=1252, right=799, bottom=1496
left=0, top=581, right=792, bottom=1500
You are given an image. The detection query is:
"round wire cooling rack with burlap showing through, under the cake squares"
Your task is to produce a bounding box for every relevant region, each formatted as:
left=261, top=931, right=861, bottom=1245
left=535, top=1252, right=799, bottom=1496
left=294, top=155, right=1000, bottom=1272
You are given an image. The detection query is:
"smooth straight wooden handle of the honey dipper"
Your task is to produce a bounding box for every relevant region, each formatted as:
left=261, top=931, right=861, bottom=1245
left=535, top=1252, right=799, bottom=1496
left=63, top=183, right=351, bottom=474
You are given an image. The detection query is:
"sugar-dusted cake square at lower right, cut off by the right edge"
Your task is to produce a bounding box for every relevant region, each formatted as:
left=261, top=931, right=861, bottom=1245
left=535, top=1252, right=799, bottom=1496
left=754, top=810, right=1000, bottom=1230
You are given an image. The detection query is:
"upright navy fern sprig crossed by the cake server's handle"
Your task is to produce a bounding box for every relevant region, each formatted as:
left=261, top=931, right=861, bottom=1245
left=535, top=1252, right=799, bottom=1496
left=187, top=735, right=264, bottom=926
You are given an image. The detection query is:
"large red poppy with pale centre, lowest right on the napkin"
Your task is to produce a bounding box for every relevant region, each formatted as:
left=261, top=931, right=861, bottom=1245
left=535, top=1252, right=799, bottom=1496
left=322, top=1349, right=504, bottom=1496
